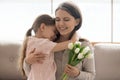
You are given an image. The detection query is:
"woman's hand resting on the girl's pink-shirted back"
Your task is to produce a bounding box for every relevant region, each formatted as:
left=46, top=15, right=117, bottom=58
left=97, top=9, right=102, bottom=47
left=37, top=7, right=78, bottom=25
left=25, top=48, right=46, bottom=64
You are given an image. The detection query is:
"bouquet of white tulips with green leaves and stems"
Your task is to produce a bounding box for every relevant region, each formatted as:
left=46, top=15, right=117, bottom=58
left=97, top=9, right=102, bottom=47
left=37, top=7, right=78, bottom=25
left=62, top=42, right=93, bottom=80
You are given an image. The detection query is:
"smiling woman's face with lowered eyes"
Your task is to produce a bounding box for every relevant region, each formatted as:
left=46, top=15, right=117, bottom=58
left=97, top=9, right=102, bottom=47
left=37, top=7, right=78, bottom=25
left=55, top=9, right=77, bottom=36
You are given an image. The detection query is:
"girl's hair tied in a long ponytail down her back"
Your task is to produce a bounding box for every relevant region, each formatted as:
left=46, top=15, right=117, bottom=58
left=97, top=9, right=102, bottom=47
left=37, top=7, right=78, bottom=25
left=18, top=14, right=55, bottom=78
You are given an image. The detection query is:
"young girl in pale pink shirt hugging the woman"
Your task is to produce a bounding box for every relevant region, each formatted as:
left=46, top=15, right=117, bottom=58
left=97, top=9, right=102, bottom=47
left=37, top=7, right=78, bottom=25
left=20, top=14, right=76, bottom=80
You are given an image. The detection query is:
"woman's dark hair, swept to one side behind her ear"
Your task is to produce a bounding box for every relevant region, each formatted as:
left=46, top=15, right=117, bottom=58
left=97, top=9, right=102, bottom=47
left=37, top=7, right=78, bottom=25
left=55, top=2, right=82, bottom=39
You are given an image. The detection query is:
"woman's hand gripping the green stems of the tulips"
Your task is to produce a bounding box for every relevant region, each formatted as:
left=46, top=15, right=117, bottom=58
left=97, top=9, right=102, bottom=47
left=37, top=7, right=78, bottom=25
left=64, top=64, right=80, bottom=77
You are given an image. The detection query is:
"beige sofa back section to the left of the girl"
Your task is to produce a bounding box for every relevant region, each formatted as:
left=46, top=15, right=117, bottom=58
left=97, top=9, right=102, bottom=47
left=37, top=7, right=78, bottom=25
left=0, top=41, right=22, bottom=80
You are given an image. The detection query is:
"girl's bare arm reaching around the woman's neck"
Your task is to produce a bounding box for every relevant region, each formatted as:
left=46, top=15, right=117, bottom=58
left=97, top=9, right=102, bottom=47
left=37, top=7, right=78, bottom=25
left=52, top=33, right=77, bottom=52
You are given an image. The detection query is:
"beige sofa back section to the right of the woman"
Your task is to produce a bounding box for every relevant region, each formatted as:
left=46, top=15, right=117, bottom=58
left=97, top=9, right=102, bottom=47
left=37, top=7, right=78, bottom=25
left=94, top=43, right=120, bottom=80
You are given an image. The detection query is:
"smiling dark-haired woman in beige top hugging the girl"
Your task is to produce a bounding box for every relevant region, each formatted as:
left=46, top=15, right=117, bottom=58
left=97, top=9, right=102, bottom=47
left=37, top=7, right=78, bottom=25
left=24, top=2, right=95, bottom=80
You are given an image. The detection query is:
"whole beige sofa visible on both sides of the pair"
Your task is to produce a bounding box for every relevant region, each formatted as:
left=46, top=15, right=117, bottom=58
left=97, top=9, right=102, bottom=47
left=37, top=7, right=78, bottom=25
left=0, top=41, right=120, bottom=80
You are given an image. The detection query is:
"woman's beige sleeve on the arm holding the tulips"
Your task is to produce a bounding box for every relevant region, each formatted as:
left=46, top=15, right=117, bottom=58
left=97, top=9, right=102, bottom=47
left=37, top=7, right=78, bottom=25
left=75, top=42, right=96, bottom=80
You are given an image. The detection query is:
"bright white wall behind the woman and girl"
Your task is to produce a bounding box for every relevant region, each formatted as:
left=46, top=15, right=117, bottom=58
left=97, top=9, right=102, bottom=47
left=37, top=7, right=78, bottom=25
left=0, top=0, right=120, bottom=42
